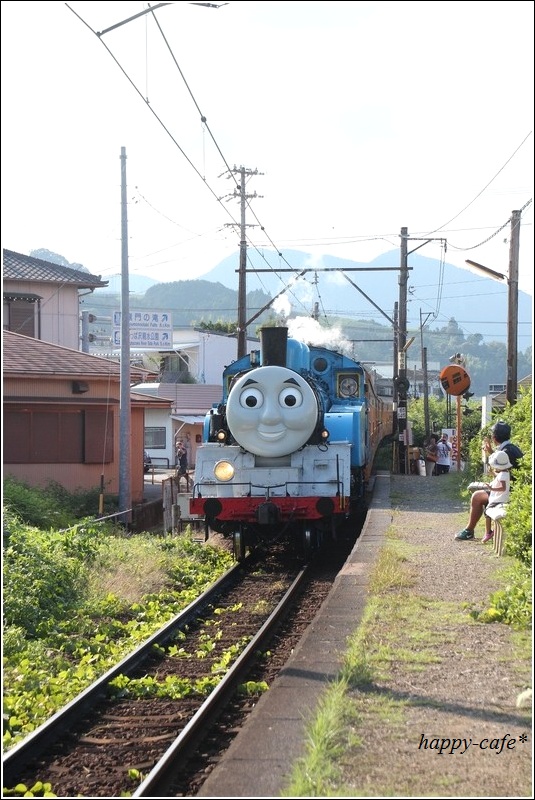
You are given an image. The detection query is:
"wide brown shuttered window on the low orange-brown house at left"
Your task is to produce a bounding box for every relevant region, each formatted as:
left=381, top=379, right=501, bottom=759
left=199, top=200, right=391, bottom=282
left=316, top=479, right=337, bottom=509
left=4, top=410, right=113, bottom=464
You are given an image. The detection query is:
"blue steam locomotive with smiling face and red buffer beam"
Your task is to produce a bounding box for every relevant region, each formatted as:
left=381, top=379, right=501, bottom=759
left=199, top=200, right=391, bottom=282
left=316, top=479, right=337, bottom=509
left=190, top=328, right=393, bottom=559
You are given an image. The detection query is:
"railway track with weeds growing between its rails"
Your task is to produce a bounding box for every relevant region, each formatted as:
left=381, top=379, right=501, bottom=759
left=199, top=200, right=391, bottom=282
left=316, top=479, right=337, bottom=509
left=3, top=540, right=346, bottom=797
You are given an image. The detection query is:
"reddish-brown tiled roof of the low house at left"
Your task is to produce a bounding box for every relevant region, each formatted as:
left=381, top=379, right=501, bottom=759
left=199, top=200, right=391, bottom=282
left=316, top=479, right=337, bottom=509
left=2, top=331, right=146, bottom=380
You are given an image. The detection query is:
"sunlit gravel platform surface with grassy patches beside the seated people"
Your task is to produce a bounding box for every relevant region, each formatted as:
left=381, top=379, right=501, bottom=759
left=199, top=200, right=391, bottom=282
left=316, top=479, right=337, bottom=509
left=344, top=476, right=533, bottom=798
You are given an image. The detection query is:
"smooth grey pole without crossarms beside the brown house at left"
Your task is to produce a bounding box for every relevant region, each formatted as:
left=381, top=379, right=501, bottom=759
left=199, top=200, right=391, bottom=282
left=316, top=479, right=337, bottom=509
left=119, top=147, right=132, bottom=527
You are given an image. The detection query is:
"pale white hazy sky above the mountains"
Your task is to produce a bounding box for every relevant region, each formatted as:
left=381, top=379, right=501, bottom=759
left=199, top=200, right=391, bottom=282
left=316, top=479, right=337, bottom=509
left=1, top=0, right=534, bottom=300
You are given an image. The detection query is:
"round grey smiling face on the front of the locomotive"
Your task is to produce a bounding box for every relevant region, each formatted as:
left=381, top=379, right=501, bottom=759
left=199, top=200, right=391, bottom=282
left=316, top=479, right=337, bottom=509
left=227, top=366, right=318, bottom=457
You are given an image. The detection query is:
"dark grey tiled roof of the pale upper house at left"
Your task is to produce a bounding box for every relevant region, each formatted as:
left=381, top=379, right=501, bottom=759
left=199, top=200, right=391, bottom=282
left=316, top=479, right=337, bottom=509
left=2, top=249, right=108, bottom=289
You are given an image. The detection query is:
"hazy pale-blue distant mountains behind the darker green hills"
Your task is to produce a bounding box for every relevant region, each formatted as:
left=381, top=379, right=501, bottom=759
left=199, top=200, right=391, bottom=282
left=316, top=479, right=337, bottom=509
left=110, top=249, right=532, bottom=351
